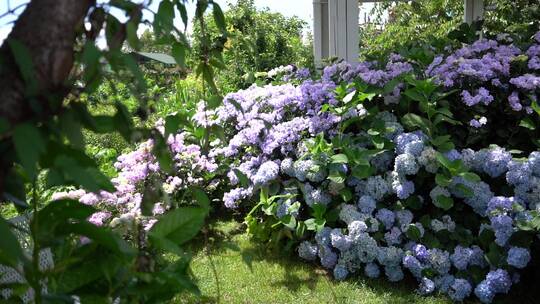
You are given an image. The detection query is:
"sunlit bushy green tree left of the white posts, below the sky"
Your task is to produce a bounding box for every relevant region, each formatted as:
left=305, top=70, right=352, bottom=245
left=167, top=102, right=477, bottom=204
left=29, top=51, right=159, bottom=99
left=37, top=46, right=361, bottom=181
left=192, top=0, right=313, bottom=92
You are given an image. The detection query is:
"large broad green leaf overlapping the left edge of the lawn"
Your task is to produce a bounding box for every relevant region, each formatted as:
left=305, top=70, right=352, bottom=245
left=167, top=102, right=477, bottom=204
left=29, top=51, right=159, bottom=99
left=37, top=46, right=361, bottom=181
left=149, top=207, right=207, bottom=245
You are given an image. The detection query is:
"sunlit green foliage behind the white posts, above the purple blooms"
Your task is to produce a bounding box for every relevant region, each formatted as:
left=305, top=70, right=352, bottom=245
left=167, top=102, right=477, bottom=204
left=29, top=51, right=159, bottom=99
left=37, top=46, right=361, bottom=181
left=360, top=0, right=540, bottom=58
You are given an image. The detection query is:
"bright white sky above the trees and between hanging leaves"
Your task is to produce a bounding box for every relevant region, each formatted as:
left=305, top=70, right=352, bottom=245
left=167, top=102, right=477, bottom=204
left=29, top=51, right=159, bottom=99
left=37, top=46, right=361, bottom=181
left=0, top=0, right=373, bottom=44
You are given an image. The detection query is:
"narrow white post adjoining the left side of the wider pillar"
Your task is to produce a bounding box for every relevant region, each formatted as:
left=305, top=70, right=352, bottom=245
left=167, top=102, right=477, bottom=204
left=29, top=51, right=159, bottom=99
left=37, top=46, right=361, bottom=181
left=313, top=0, right=329, bottom=68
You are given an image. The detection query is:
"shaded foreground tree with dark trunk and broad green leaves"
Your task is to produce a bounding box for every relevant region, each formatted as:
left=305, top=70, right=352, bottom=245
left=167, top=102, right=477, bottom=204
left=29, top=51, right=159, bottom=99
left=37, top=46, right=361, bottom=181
left=0, top=0, right=226, bottom=303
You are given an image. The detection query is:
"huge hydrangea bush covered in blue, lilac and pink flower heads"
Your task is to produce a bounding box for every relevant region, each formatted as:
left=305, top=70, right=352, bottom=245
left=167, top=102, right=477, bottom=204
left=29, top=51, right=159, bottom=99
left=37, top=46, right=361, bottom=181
left=57, top=33, right=540, bottom=303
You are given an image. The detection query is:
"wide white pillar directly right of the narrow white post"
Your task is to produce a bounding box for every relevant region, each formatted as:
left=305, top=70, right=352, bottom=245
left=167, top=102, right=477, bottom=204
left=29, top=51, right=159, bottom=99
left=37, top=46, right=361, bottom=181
left=328, top=0, right=359, bottom=62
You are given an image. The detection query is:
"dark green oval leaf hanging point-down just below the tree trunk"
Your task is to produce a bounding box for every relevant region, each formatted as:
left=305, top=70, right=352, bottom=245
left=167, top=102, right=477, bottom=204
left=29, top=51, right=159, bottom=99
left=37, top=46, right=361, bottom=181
left=13, top=123, right=45, bottom=178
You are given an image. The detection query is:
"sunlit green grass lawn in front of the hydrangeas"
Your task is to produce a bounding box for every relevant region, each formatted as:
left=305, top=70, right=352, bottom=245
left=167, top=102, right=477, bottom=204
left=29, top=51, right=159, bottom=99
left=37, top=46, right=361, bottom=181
left=175, top=221, right=451, bottom=304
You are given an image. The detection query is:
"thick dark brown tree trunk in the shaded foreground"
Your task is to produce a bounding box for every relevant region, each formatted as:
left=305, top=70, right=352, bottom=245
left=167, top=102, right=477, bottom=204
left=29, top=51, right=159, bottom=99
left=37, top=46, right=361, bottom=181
left=0, top=0, right=95, bottom=194
